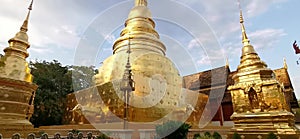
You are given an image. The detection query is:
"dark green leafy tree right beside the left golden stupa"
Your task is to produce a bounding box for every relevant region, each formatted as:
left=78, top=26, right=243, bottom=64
left=30, top=60, right=73, bottom=127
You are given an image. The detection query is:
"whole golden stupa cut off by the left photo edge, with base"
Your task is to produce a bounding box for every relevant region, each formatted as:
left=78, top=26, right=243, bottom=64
left=0, top=1, right=37, bottom=133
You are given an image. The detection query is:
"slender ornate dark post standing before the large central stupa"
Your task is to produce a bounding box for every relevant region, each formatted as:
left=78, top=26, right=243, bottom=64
left=120, top=34, right=135, bottom=129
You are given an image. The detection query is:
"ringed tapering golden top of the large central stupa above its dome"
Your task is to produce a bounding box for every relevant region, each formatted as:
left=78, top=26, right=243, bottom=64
left=113, top=0, right=166, bottom=55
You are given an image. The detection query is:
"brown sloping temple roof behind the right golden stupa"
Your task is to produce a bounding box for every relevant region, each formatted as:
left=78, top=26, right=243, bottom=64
left=183, top=66, right=299, bottom=108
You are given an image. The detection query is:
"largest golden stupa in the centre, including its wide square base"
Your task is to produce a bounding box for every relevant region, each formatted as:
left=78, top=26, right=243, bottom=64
left=65, top=0, right=208, bottom=125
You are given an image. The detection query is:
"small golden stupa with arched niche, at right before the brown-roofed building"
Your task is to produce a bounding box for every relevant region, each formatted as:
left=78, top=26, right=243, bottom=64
left=228, top=7, right=299, bottom=139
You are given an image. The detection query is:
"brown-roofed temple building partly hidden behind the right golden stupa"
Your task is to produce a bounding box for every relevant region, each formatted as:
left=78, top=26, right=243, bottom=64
left=183, top=61, right=299, bottom=125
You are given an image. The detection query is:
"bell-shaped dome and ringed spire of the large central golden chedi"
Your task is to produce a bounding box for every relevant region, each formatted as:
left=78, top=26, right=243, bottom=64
left=95, top=0, right=182, bottom=122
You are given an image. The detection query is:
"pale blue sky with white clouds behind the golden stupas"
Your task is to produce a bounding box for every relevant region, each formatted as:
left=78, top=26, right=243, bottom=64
left=0, top=0, right=300, bottom=98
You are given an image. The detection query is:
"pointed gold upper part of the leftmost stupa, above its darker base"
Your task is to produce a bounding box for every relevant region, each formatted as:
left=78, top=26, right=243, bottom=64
left=0, top=0, right=33, bottom=82
